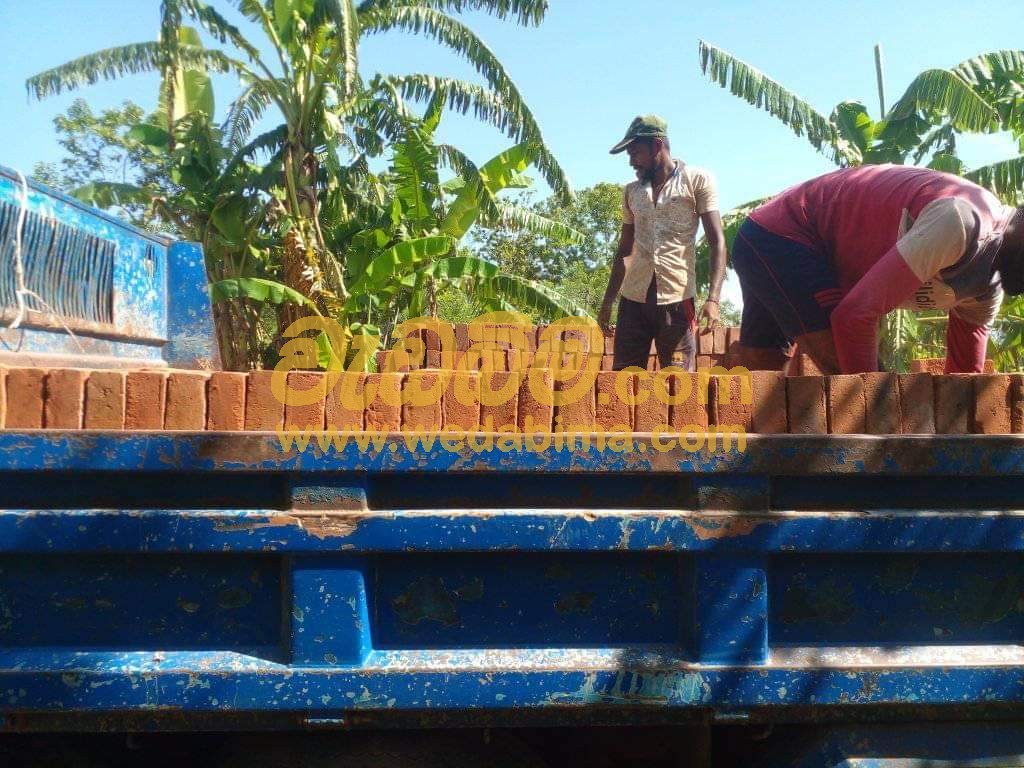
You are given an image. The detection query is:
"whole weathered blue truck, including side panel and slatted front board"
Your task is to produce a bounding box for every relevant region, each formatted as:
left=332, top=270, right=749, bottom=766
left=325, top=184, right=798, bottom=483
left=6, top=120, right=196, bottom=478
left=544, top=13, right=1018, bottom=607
left=6, top=165, right=1024, bottom=768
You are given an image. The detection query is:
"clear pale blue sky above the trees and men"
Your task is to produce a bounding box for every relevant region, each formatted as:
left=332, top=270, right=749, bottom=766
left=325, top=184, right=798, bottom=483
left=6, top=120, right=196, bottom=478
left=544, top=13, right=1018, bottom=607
left=0, top=0, right=1024, bottom=303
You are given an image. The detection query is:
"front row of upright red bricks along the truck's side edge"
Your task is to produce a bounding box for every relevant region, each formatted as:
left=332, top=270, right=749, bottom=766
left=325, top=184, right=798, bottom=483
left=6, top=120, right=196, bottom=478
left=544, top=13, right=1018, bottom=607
left=0, top=368, right=1024, bottom=434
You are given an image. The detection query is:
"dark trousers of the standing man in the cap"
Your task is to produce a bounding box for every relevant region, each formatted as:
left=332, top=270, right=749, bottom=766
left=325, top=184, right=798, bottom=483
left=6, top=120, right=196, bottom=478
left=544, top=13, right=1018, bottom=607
left=611, top=278, right=696, bottom=371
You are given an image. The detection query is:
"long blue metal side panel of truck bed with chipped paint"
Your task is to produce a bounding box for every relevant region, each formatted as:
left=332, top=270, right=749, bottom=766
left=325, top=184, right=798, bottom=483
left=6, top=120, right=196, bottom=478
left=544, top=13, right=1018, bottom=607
left=0, top=431, right=1024, bottom=733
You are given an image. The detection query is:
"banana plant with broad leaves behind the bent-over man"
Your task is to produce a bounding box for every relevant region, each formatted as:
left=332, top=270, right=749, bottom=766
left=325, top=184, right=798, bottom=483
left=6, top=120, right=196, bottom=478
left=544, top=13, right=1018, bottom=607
left=699, top=41, right=1024, bottom=371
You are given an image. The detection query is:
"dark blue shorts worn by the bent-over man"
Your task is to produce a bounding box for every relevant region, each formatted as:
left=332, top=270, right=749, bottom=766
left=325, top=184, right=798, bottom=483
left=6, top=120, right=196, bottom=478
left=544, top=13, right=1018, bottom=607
left=732, top=219, right=843, bottom=349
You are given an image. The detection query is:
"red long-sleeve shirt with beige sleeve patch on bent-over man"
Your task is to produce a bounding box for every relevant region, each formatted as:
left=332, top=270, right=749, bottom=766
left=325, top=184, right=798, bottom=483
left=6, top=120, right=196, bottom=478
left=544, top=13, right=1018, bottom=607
left=751, top=165, right=1014, bottom=373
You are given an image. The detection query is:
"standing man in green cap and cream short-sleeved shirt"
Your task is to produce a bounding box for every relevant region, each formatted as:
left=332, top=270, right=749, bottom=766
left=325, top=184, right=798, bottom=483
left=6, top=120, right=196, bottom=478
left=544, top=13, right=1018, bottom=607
left=598, top=115, right=726, bottom=371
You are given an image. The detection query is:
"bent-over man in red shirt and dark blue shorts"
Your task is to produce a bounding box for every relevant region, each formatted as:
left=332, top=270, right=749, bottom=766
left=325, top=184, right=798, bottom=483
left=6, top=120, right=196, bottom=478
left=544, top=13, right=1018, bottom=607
left=732, top=165, right=1024, bottom=373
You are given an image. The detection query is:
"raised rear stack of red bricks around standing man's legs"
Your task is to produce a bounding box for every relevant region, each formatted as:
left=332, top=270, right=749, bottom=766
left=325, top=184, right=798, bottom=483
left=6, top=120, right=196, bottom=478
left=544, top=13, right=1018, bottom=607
left=377, top=324, right=739, bottom=373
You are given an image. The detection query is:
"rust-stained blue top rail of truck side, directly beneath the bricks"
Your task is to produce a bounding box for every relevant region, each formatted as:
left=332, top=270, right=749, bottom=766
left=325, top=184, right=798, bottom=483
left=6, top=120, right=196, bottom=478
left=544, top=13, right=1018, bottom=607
left=0, top=430, right=1024, bottom=478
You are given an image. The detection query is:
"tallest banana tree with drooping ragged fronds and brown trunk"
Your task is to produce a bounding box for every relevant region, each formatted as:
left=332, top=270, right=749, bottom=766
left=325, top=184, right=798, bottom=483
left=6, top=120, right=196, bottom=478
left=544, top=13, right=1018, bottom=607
left=28, top=0, right=569, bottom=327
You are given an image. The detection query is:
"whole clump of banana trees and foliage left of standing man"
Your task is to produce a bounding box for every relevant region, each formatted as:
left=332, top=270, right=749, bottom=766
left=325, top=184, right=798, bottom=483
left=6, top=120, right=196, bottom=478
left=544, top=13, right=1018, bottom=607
left=27, top=0, right=573, bottom=367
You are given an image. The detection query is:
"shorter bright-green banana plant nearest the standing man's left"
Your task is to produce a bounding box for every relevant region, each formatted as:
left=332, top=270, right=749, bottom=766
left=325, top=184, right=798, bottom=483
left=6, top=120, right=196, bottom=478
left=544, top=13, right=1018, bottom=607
left=339, top=94, right=587, bottom=356
